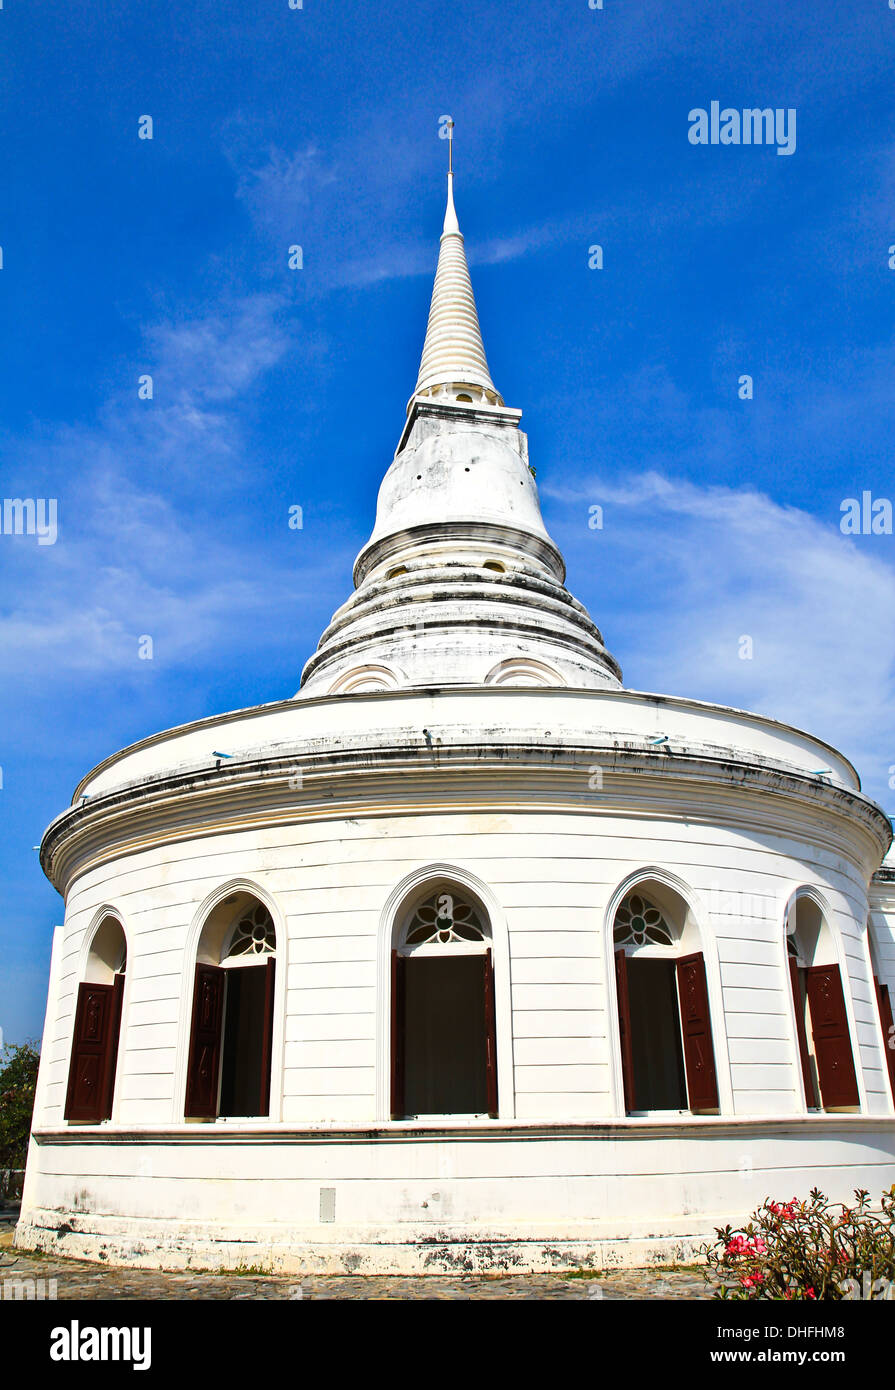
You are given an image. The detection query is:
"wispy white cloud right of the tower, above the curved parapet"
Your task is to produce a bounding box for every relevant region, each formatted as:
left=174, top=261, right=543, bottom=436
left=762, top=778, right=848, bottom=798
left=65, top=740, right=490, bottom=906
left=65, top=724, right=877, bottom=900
left=545, top=471, right=895, bottom=810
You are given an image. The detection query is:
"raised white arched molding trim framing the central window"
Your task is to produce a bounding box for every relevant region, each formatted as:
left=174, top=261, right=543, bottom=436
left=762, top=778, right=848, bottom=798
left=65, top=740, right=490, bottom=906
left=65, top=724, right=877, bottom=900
left=377, top=863, right=516, bottom=1123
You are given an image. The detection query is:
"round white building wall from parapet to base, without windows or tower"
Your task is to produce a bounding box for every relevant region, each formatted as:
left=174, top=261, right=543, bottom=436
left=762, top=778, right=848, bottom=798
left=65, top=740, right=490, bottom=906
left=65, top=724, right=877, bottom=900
left=19, top=691, right=895, bottom=1269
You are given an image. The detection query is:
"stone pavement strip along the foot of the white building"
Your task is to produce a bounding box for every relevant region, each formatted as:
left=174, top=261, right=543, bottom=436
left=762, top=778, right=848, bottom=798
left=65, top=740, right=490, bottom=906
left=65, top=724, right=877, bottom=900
left=0, top=1213, right=707, bottom=1301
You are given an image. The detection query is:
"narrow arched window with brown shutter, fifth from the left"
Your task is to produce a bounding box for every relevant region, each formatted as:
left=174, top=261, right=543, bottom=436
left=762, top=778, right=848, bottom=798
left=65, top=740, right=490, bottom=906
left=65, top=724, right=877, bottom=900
left=787, top=894, right=860, bottom=1111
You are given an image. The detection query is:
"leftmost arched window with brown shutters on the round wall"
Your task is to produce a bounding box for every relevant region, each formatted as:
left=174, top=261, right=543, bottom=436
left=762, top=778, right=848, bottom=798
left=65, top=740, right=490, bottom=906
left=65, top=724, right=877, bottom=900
left=65, top=917, right=128, bottom=1125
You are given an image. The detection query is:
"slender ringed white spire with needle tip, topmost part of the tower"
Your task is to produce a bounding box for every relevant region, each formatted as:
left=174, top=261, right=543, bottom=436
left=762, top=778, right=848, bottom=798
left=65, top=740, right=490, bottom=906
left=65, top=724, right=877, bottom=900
left=411, top=121, right=503, bottom=404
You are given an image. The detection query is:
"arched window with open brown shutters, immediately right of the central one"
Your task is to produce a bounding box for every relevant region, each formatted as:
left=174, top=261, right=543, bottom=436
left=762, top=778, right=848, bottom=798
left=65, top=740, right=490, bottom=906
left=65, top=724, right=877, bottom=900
left=613, top=883, right=719, bottom=1115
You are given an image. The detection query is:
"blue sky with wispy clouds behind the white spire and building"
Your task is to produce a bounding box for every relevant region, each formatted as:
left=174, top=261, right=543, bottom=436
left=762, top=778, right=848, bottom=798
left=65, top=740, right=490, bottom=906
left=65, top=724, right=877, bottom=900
left=0, top=0, right=895, bottom=1041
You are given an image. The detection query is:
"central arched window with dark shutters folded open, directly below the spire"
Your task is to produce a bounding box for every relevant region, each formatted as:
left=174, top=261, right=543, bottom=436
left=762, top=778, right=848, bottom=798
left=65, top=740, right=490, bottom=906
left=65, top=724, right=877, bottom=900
left=392, top=883, right=498, bottom=1119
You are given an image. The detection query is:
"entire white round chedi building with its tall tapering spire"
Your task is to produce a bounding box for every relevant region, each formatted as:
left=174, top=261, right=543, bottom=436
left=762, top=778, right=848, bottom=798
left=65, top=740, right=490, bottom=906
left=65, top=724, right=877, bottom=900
left=17, top=157, right=895, bottom=1273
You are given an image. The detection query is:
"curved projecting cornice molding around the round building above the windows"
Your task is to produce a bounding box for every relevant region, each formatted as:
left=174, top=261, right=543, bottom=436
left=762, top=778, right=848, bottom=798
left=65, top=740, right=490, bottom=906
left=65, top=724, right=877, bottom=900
left=40, top=731, right=889, bottom=894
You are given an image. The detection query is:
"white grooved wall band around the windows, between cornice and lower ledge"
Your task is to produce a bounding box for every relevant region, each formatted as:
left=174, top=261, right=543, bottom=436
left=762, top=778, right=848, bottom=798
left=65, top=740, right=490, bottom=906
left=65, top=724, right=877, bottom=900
left=31, top=812, right=891, bottom=1125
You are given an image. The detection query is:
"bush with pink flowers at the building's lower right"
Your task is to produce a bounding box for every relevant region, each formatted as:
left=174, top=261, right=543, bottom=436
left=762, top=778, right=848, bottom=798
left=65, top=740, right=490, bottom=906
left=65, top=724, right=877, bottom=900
left=702, top=1186, right=895, bottom=1300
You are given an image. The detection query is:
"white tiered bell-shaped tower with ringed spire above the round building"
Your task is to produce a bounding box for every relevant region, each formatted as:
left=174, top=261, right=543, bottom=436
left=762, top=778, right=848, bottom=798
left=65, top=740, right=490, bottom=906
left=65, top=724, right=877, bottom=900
left=300, top=156, right=621, bottom=696
